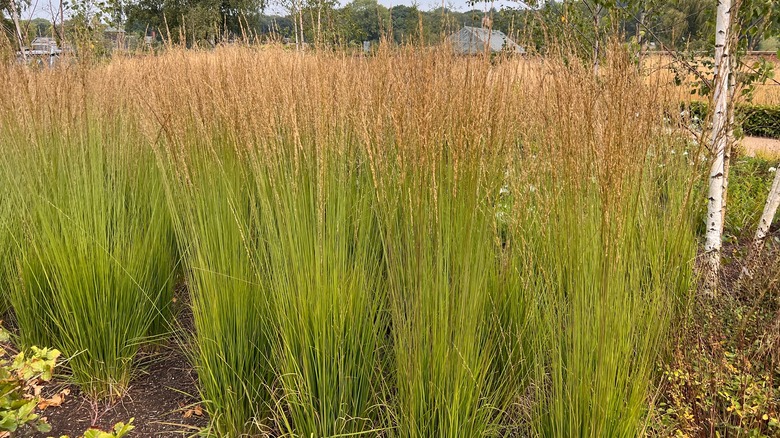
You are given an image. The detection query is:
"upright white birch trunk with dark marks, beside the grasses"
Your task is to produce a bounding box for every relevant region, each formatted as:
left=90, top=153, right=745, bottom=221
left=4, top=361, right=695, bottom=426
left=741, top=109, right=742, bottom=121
left=704, top=0, right=731, bottom=296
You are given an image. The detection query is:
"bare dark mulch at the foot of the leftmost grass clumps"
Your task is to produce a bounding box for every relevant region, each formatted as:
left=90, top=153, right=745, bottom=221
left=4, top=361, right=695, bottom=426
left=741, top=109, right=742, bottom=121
left=24, top=347, right=208, bottom=438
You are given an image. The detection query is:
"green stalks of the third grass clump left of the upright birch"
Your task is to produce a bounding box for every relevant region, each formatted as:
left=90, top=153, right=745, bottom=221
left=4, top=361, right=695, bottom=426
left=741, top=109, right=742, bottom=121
left=255, top=141, right=387, bottom=436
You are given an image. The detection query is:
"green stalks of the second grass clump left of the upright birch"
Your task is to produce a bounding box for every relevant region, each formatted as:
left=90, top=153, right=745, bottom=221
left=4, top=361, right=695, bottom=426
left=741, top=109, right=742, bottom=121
left=380, top=153, right=523, bottom=437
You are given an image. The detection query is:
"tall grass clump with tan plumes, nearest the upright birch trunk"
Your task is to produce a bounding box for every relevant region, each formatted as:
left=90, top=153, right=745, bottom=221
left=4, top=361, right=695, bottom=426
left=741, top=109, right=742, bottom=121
left=509, top=51, right=696, bottom=437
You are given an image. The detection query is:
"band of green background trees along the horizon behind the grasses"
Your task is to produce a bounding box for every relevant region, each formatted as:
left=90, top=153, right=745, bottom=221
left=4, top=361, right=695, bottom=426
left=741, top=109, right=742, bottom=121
left=0, top=0, right=780, bottom=54
